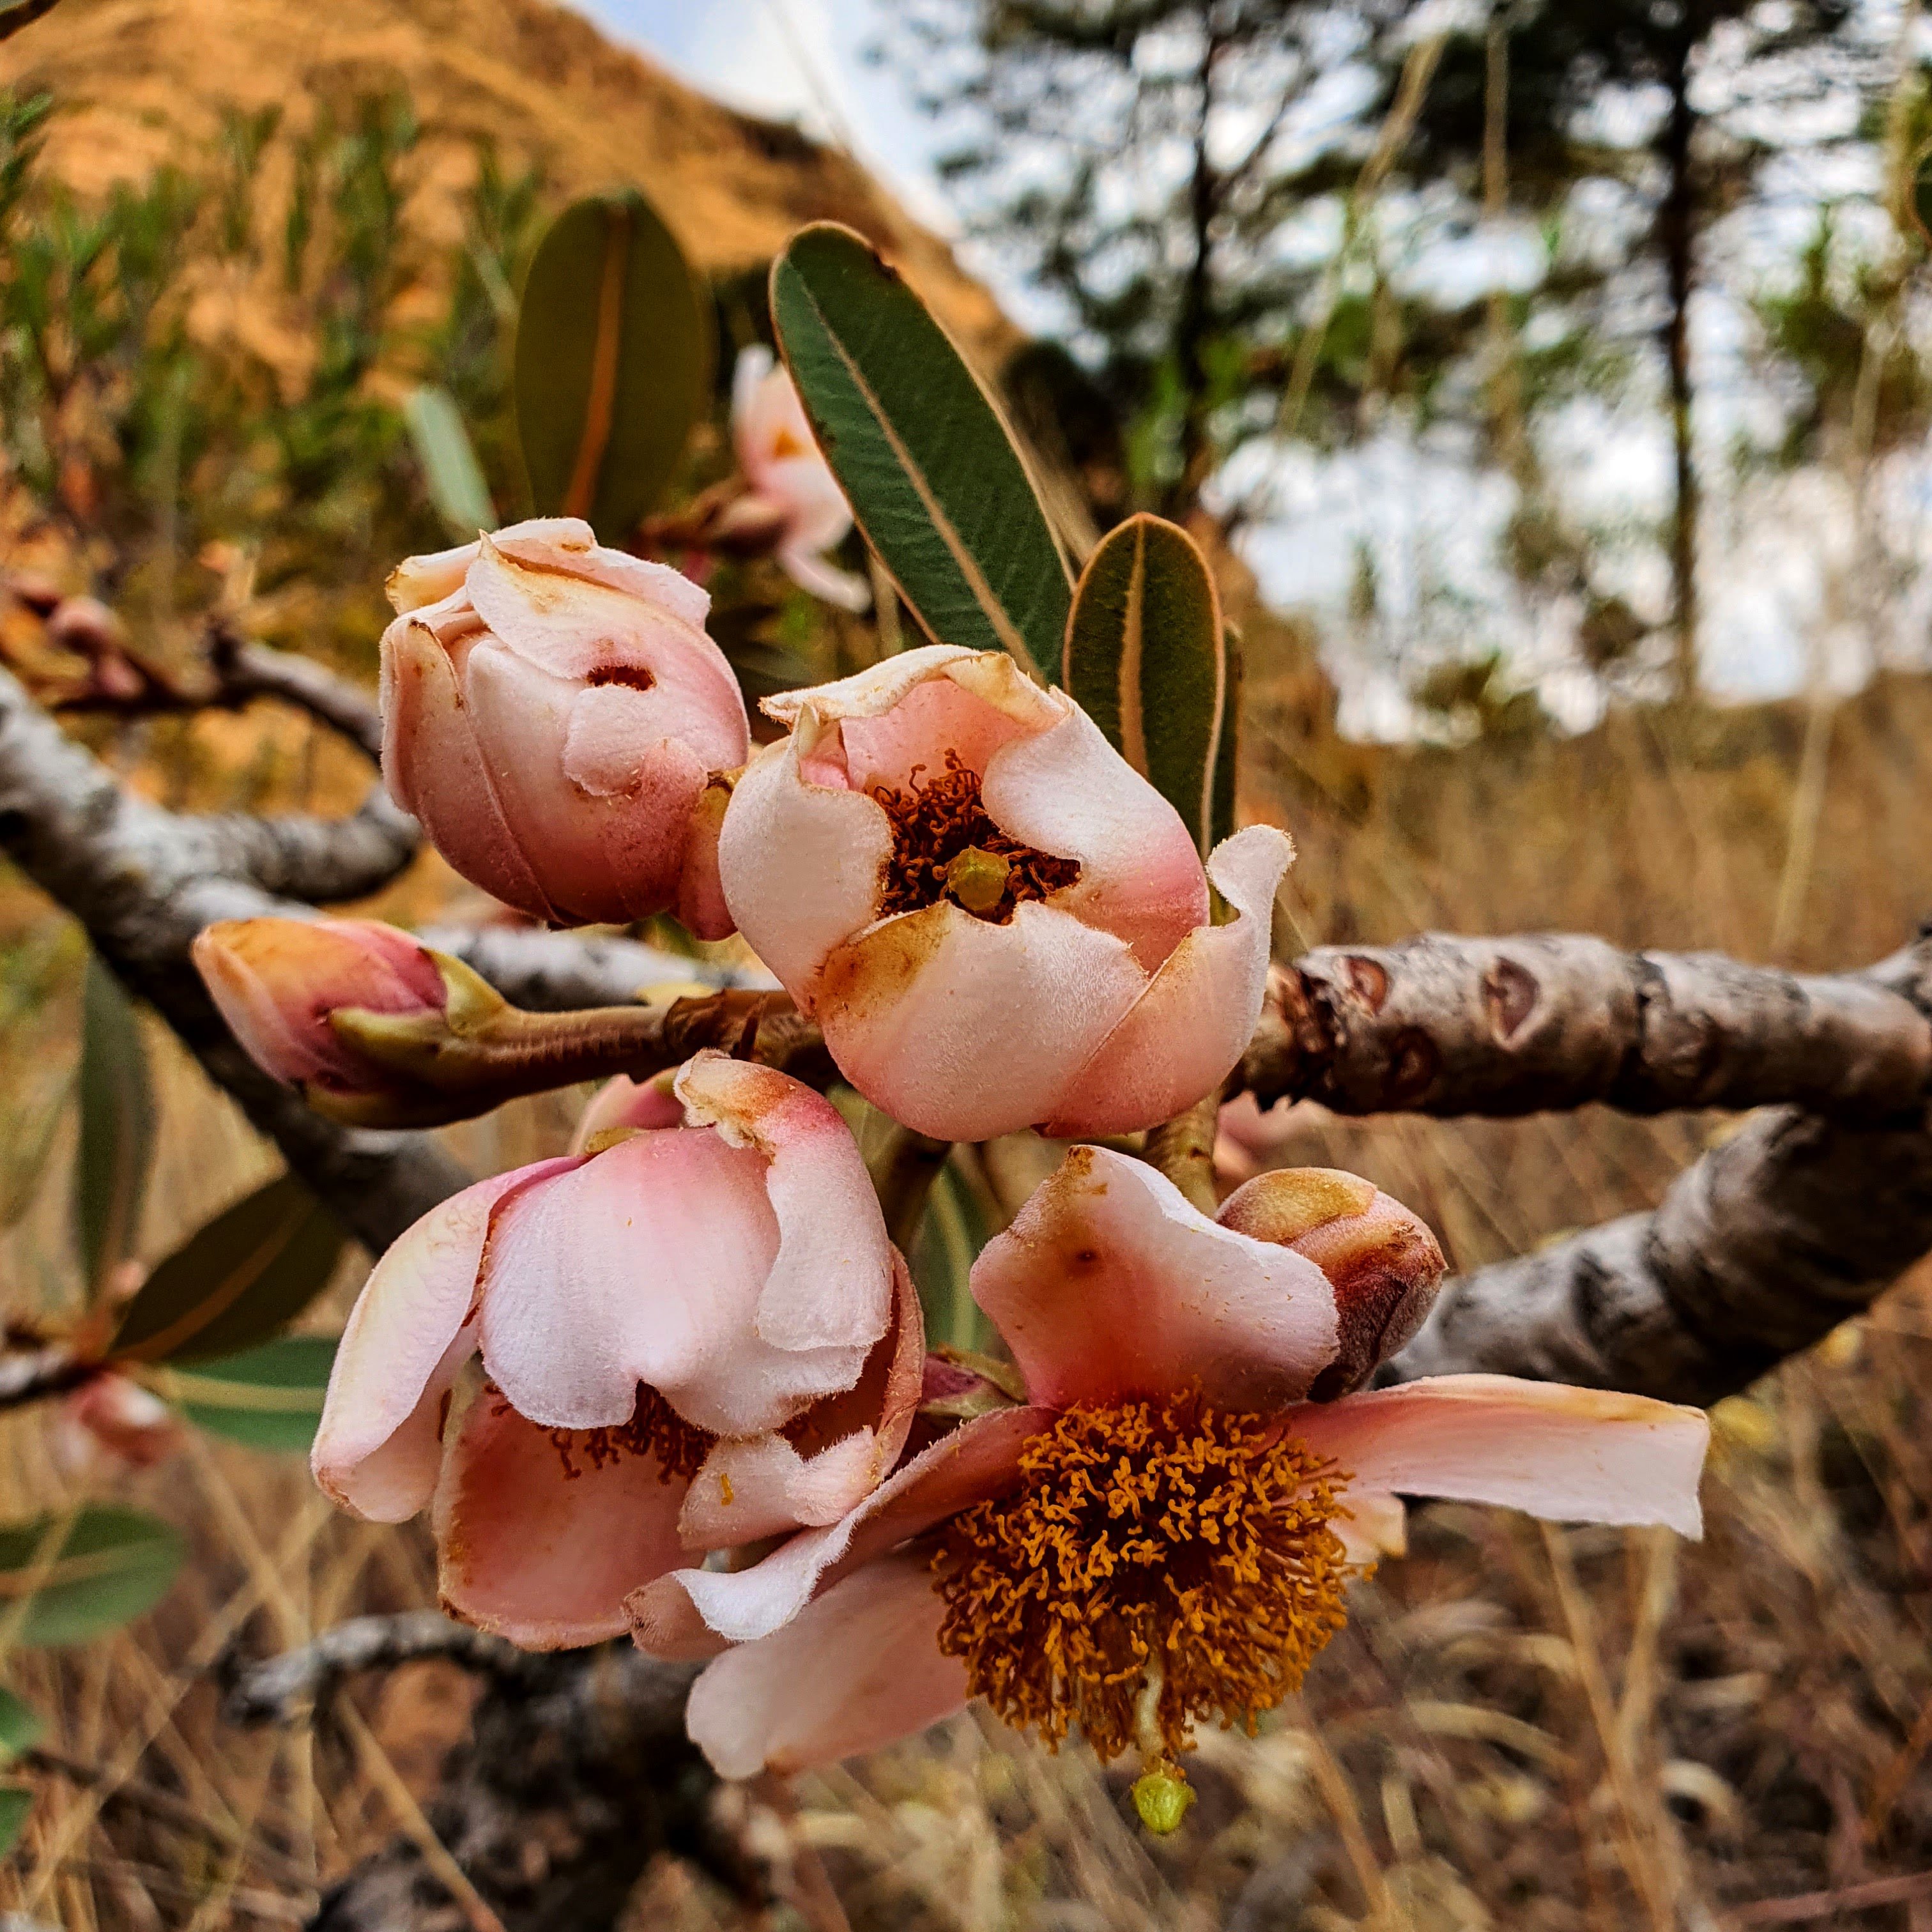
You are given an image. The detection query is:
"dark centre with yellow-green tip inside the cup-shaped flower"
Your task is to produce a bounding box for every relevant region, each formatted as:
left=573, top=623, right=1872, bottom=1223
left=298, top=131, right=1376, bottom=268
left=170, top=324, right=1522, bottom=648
left=871, top=751, right=1080, bottom=925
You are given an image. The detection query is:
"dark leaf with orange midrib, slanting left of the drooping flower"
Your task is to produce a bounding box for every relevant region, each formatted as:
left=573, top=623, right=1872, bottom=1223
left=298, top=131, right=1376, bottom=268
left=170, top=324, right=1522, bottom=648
left=108, top=1175, right=344, bottom=1362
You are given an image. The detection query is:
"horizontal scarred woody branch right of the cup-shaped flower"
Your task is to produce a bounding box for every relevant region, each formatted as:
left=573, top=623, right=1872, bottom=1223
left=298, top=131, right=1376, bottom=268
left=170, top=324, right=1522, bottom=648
left=1238, top=933, right=1932, bottom=1124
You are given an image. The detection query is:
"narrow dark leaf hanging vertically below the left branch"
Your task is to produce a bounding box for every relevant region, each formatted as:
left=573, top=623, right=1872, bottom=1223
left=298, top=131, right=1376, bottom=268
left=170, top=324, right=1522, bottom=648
left=73, top=953, right=155, bottom=1294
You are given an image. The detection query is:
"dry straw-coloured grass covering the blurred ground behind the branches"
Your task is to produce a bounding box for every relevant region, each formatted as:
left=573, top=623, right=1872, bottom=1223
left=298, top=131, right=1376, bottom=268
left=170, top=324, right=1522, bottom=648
left=0, top=680, right=1932, bottom=1932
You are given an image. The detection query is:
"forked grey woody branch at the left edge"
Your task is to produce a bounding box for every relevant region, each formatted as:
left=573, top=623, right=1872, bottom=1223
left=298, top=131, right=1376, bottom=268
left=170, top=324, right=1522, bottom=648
left=0, top=672, right=468, bottom=1252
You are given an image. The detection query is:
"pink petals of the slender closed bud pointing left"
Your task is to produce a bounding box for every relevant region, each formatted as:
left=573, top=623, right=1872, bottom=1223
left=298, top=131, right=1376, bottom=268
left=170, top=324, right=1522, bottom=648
left=193, top=919, right=450, bottom=1098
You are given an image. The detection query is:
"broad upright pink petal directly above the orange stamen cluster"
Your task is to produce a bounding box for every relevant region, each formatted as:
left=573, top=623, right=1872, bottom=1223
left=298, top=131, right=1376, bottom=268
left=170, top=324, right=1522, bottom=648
left=972, top=1147, right=1337, bottom=1413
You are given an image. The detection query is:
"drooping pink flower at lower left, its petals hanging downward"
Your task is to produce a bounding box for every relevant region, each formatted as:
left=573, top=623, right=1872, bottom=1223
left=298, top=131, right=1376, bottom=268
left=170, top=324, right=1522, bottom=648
left=313, top=1053, right=923, bottom=1648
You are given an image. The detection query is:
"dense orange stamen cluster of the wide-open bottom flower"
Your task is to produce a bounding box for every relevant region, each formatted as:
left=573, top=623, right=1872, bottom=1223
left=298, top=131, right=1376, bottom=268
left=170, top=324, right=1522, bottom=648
left=933, top=1391, right=1349, bottom=1758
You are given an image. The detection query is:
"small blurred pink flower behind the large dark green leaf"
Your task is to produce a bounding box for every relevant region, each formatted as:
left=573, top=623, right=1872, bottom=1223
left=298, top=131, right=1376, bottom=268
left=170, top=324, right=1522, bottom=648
left=730, top=344, right=871, bottom=611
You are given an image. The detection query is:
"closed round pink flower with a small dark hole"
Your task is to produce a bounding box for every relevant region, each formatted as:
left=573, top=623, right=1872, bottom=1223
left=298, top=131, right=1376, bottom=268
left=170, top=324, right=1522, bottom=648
left=383, top=518, right=749, bottom=939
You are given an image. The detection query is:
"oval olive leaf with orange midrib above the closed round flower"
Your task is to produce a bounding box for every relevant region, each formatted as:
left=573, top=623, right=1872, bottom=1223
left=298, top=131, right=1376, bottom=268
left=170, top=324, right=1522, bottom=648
left=516, top=187, right=717, bottom=543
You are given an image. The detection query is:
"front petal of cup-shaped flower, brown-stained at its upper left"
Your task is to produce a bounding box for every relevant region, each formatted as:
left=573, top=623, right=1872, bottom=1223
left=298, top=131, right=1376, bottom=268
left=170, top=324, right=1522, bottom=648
left=815, top=900, right=1146, bottom=1140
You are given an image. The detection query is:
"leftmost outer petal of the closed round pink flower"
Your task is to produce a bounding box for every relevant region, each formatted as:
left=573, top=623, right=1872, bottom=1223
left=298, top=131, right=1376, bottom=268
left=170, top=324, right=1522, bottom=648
left=383, top=618, right=556, bottom=919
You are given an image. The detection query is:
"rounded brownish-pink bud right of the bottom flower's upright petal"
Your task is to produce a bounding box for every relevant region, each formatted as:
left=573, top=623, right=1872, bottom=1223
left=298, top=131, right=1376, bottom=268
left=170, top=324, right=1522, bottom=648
left=1215, top=1167, right=1445, bottom=1402
